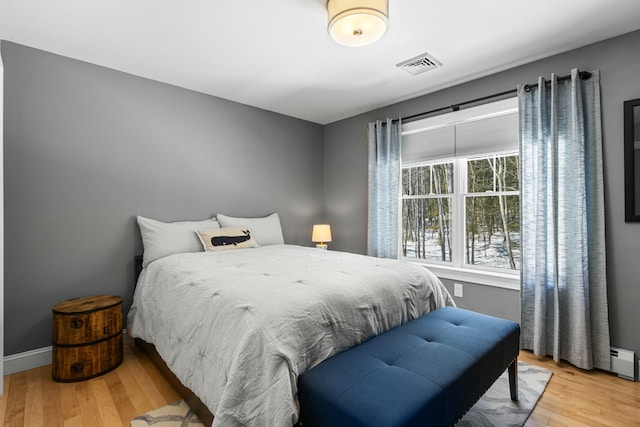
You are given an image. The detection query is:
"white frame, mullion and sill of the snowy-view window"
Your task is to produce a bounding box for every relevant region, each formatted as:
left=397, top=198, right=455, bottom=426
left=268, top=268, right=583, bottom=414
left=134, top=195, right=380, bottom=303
left=398, top=99, right=520, bottom=290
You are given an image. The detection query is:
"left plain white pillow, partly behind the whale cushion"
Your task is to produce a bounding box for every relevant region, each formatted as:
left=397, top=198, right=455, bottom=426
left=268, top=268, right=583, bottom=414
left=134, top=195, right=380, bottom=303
left=137, top=215, right=220, bottom=267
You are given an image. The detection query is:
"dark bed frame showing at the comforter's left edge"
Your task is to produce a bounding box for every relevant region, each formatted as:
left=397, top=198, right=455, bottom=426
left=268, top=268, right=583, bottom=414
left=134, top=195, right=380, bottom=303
left=134, top=255, right=213, bottom=426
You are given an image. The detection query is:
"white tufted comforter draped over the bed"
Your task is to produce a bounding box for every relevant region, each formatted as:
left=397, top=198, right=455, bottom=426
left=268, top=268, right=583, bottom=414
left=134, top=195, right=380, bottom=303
left=127, top=245, right=453, bottom=427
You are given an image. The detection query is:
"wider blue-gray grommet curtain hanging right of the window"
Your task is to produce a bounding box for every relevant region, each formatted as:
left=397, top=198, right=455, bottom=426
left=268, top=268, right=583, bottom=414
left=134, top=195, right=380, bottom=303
left=518, top=69, right=610, bottom=369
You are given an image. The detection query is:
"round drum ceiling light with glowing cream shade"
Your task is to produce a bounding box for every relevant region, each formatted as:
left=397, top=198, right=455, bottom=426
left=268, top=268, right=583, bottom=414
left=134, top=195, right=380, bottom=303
left=327, top=0, right=389, bottom=47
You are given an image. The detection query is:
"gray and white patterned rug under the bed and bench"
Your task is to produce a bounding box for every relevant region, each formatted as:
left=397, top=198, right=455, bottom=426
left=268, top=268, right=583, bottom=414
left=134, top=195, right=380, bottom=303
left=131, top=362, right=551, bottom=427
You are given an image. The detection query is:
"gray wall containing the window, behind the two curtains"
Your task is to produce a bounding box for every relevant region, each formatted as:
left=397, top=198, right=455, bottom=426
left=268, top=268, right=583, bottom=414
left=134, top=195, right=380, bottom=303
left=324, top=31, right=640, bottom=354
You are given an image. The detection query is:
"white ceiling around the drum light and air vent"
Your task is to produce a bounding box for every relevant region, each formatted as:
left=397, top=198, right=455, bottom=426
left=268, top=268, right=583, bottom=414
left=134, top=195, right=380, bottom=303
left=0, top=0, right=640, bottom=124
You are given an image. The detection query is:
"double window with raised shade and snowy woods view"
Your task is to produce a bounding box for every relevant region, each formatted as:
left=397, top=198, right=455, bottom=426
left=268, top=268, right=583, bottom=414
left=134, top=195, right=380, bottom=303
left=399, top=99, right=520, bottom=287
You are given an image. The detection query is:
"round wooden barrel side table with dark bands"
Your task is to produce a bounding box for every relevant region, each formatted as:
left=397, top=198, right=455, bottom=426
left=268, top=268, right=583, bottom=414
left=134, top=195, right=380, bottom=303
left=51, top=295, right=123, bottom=382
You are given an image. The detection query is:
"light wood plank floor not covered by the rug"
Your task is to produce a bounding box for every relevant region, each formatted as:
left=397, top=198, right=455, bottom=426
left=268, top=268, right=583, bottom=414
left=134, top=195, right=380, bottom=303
left=0, top=343, right=640, bottom=427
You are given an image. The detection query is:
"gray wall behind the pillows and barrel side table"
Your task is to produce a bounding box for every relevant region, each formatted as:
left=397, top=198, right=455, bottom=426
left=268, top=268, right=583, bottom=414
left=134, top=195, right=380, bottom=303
left=1, top=41, right=323, bottom=354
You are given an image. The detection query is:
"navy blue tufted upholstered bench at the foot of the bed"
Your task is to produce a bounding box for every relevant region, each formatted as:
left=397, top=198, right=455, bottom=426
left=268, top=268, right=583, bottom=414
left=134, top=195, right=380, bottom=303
left=298, top=307, right=520, bottom=427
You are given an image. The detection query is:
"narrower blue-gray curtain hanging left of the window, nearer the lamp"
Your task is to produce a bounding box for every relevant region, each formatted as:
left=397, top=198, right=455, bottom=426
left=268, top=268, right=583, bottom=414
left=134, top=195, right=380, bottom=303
left=367, top=119, right=401, bottom=258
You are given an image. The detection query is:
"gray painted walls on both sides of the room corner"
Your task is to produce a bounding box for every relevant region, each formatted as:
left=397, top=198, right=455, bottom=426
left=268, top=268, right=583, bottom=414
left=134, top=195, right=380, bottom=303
left=2, top=32, right=640, bottom=362
